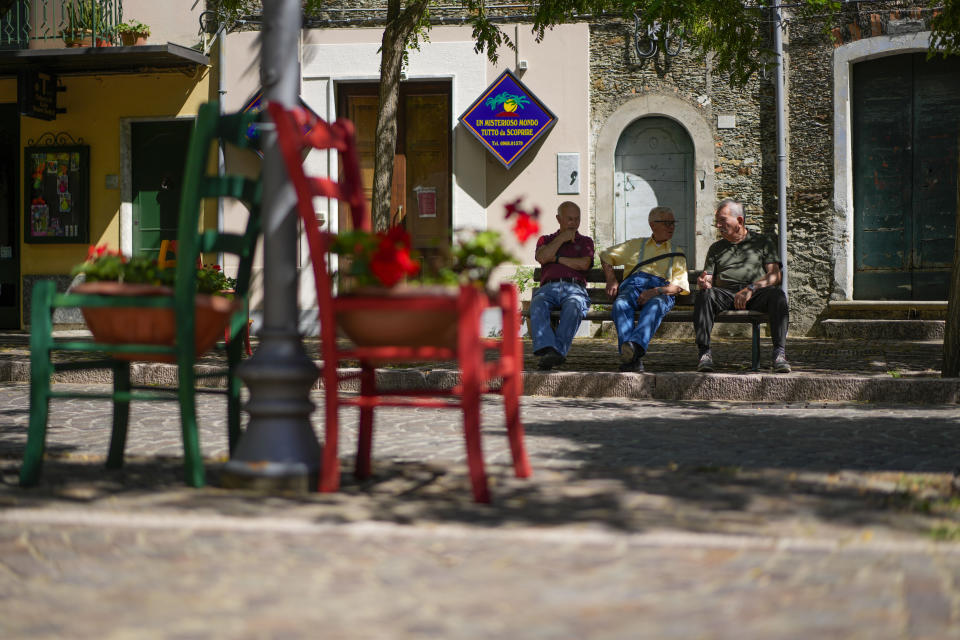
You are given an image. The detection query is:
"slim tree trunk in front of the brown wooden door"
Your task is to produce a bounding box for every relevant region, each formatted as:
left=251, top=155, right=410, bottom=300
left=370, top=0, right=427, bottom=230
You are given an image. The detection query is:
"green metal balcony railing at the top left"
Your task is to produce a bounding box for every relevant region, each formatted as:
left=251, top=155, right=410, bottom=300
left=0, top=0, right=123, bottom=49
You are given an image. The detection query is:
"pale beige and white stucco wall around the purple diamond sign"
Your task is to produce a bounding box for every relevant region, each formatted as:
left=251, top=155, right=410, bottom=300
left=223, top=24, right=593, bottom=304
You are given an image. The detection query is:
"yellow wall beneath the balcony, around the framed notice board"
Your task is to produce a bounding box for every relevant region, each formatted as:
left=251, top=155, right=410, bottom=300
left=19, top=71, right=216, bottom=275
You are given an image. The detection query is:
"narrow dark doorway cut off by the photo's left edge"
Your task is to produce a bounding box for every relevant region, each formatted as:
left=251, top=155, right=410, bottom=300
left=0, top=103, right=20, bottom=329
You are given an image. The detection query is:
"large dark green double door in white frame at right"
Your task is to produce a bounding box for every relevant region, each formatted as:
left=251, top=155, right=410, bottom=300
left=852, top=53, right=960, bottom=300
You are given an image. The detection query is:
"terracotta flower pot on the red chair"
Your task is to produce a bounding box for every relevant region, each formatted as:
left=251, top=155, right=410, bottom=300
left=337, top=287, right=457, bottom=348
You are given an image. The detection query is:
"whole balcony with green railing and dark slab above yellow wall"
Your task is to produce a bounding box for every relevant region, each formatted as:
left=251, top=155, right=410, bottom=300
left=0, top=0, right=209, bottom=76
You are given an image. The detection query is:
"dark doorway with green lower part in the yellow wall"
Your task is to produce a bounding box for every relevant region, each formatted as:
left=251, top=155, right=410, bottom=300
left=130, top=120, right=193, bottom=257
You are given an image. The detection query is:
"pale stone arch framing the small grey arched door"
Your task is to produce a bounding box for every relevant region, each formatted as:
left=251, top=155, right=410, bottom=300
left=594, top=93, right=715, bottom=262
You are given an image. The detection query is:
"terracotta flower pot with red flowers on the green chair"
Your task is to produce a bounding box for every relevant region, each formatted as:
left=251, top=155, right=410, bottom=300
left=71, top=282, right=242, bottom=362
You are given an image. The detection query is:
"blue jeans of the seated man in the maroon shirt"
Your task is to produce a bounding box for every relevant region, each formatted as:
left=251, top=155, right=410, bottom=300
left=530, top=282, right=590, bottom=357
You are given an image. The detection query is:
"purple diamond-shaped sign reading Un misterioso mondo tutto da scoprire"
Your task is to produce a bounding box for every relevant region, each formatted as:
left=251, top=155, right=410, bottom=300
left=460, top=70, right=557, bottom=169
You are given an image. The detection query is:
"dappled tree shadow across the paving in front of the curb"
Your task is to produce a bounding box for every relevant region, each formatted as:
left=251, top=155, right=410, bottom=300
left=0, top=400, right=960, bottom=537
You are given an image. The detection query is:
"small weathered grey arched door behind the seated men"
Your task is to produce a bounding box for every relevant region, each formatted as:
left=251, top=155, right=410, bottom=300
left=613, top=116, right=696, bottom=265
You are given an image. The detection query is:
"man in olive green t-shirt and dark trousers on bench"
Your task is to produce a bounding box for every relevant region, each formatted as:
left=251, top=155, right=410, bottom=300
left=693, top=198, right=790, bottom=373
